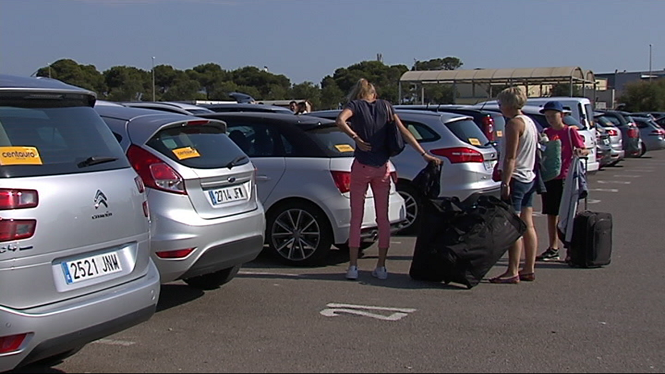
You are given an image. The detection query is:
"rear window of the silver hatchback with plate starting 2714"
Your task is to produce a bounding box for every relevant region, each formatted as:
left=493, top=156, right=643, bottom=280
left=146, top=125, right=249, bottom=169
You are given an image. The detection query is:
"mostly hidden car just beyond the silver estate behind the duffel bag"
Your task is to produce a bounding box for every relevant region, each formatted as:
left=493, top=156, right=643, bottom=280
left=395, top=104, right=506, bottom=149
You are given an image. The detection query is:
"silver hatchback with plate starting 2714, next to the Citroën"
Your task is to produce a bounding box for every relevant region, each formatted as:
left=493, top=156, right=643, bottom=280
left=96, top=106, right=265, bottom=289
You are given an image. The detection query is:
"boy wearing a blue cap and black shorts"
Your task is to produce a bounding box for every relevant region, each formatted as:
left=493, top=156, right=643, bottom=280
left=536, top=101, right=589, bottom=261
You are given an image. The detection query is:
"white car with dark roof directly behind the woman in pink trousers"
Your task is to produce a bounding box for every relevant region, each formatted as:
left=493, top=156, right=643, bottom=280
left=195, top=111, right=406, bottom=265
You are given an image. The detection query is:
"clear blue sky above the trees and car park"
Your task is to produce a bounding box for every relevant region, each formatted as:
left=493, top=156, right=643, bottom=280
left=0, top=0, right=665, bottom=84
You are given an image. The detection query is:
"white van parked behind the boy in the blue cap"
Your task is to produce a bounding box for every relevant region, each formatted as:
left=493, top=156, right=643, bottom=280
left=474, top=96, right=600, bottom=172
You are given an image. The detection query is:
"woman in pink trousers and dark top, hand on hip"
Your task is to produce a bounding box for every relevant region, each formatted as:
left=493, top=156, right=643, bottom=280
left=335, top=79, right=442, bottom=280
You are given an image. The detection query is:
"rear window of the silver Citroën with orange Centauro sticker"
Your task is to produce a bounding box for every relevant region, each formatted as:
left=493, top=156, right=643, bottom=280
left=0, top=94, right=130, bottom=178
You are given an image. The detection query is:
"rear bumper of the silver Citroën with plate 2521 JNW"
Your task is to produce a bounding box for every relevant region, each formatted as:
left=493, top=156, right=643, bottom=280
left=0, top=261, right=160, bottom=372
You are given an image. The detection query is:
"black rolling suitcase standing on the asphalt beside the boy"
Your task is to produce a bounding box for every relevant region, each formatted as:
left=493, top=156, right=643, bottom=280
left=567, top=158, right=612, bottom=268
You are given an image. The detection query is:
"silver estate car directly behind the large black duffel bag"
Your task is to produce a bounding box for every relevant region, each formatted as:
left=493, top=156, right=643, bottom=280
left=311, top=109, right=500, bottom=234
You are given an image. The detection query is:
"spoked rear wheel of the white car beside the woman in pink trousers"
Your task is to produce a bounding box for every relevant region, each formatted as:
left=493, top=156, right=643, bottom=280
left=266, top=201, right=333, bottom=266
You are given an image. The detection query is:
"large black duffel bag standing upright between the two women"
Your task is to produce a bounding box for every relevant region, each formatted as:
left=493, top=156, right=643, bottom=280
left=409, top=194, right=526, bottom=288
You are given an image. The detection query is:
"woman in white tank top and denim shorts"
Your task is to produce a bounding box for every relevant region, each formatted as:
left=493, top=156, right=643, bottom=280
left=490, top=87, right=539, bottom=284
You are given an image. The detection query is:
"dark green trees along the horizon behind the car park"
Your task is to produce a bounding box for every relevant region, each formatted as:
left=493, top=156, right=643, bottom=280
left=36, top=57, right=665, bottom=111
